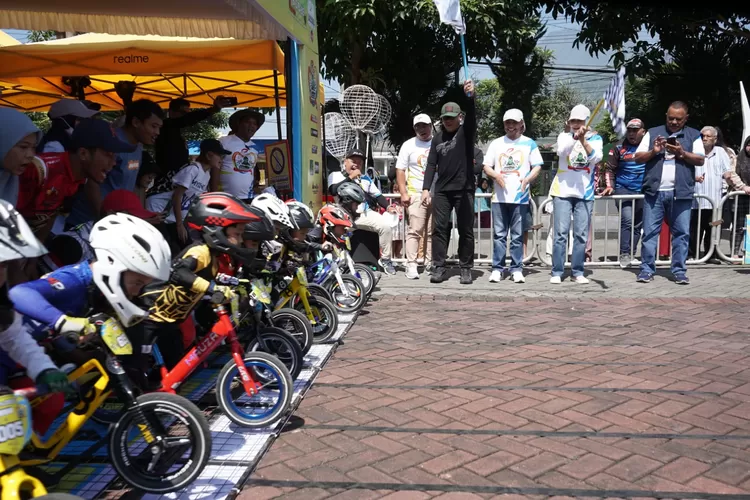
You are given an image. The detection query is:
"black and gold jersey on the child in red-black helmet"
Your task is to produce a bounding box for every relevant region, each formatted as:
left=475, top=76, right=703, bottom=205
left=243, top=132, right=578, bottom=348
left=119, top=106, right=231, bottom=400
left=141, top=243, right=219, bottom=323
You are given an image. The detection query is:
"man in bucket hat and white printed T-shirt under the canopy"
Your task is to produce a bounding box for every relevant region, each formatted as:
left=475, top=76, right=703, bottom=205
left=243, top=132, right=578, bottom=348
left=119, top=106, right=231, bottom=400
left=211, top=109, right=266, bottom=201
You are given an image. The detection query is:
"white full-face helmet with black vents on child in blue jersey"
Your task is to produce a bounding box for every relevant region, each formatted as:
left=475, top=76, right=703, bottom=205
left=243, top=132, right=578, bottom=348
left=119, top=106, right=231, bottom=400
left=89, top=213, right=172, bottom=328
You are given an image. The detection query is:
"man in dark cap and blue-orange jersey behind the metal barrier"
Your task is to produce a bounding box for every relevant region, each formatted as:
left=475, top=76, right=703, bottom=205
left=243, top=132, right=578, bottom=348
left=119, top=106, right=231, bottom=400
left=603, top=118, right=646, bottom=269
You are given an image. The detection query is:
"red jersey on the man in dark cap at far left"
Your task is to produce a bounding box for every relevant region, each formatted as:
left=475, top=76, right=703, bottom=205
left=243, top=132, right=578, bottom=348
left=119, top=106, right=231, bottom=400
left=16, top=153, right=86, bottom=232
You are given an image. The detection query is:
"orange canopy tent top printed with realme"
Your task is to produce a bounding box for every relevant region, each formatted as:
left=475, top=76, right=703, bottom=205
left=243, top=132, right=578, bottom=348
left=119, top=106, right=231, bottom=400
left=0, top=33, right=286, bottom=111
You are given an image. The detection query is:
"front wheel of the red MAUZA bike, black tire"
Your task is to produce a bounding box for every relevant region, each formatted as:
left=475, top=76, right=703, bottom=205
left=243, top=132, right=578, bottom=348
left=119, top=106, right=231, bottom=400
left=216, top=352, right=294, bottom=429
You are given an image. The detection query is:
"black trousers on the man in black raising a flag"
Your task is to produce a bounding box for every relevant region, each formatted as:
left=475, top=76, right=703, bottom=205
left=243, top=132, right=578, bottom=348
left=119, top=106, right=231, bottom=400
left=432, top=190, right=474, bottom=269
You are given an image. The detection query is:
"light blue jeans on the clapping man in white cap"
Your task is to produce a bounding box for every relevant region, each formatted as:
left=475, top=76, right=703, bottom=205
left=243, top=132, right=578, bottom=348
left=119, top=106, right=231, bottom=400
left=552, top=196, right=594, bottom=278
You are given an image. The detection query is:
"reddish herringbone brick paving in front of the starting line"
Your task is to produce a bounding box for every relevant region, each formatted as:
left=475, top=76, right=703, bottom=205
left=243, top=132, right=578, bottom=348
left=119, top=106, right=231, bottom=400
left=241, top=266, right=750, bottom=499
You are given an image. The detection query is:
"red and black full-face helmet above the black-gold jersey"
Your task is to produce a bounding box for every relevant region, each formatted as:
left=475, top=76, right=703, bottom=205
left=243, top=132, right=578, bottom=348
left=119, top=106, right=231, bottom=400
left=185, top=193, right=260, bottom=262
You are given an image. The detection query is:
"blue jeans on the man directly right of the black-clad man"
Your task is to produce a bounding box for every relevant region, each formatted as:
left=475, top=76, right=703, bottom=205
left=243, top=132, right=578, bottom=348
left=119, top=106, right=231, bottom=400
left=492, top=203, right=529, bottom=273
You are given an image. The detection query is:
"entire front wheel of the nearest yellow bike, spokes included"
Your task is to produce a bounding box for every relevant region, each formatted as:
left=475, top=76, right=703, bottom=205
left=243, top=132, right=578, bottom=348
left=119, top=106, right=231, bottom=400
left=109, top=393, right=211, bottom=493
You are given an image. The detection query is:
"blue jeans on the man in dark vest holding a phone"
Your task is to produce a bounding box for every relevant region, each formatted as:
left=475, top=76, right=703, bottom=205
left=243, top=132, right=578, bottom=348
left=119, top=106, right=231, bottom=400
left=641, top=191, right=693, bottom=276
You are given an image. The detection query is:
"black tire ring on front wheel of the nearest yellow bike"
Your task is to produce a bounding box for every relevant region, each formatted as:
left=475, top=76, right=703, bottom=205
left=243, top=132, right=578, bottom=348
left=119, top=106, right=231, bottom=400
left=109, top=392, right=212, bottom=494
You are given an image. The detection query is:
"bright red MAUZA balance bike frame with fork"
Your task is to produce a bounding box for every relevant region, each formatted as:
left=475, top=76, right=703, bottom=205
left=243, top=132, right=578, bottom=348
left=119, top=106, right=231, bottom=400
left=153, top=305, right=262, bottom=396
